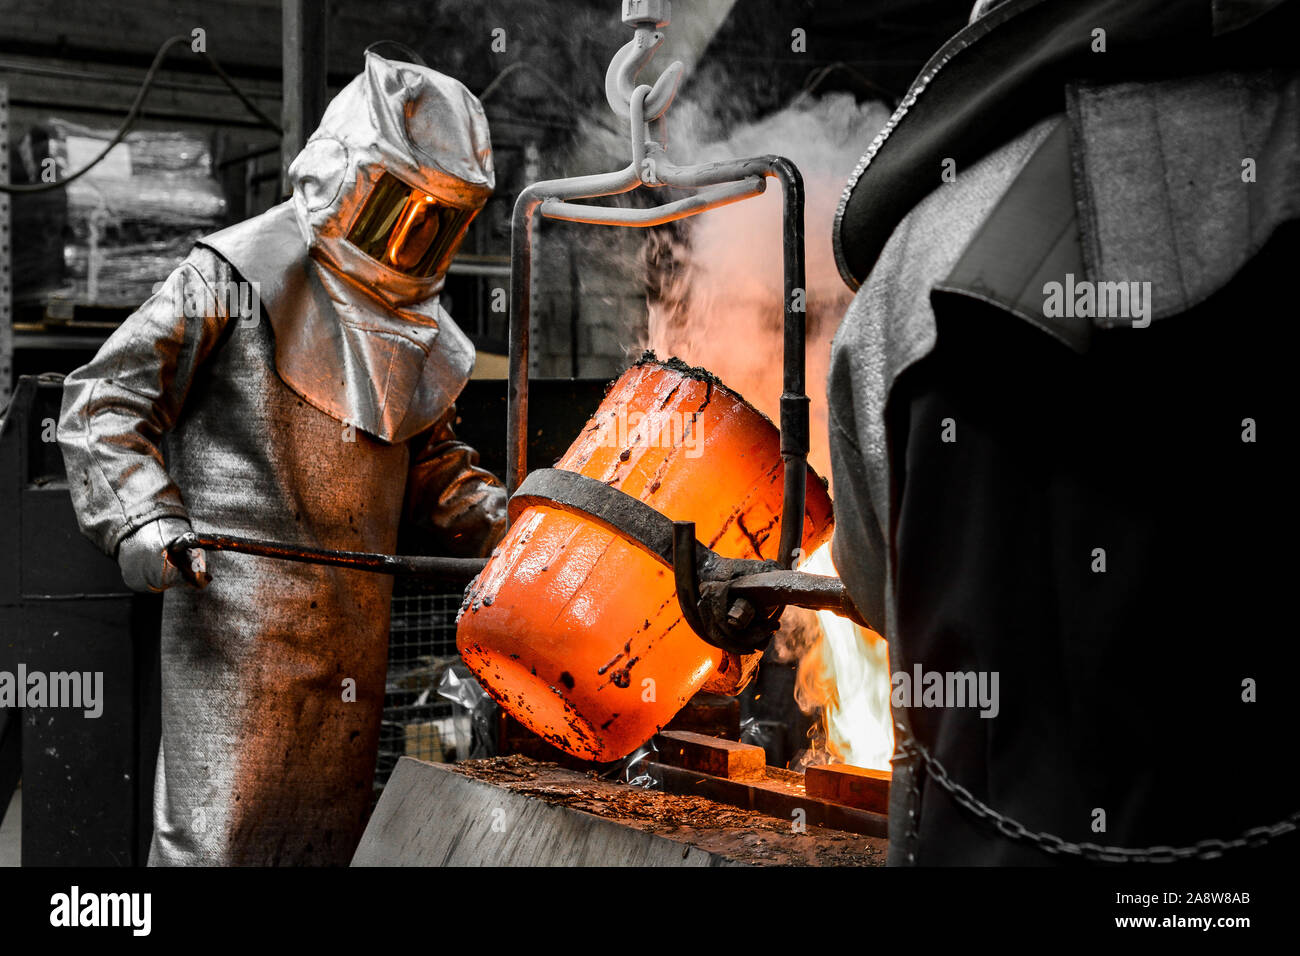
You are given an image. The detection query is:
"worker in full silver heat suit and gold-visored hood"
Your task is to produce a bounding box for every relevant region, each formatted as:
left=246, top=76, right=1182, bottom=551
left=59, top=53, right=506, bottom=865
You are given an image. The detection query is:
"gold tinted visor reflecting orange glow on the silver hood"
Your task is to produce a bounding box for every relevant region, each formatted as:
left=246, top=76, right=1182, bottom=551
left=347, top=173, right=478, bottom=278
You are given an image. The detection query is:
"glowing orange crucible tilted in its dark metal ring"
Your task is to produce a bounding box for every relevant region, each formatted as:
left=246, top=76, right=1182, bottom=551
left=456, top=356, right=837, bottom=761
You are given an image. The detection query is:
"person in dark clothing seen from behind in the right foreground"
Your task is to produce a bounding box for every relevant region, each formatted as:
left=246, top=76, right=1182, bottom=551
left=829, top=0, right=1300, bottom=865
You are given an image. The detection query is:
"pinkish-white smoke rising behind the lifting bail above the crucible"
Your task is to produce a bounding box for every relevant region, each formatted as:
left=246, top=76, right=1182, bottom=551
left=646, top=94, right=889, bottom=477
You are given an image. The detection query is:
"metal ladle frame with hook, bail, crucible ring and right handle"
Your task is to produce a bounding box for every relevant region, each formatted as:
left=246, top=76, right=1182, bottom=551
left=506, top=0, right=866, bottom=653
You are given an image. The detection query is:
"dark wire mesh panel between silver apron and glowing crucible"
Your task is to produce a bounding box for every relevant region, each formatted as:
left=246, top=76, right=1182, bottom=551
left=374, top=585, right=471, bottom=792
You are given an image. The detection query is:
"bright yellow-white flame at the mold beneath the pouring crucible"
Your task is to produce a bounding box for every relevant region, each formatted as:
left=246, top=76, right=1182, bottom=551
left=796, top=544, right=893, bottom=770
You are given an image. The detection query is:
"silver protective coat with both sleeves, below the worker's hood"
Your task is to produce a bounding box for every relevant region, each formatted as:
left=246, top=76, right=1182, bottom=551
left=59, top=247, right=504, bottom=865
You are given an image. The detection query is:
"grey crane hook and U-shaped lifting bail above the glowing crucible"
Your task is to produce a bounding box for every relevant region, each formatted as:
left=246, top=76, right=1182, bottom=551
left=506, top=0, right=809, bottom=567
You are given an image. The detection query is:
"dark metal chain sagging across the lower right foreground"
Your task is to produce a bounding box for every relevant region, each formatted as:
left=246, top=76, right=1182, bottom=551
left=894, top=723, right=1300, bottom=864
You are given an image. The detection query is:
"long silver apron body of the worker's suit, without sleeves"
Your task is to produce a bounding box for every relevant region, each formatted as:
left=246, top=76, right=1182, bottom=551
left=150, top=256, right=410, bottom=865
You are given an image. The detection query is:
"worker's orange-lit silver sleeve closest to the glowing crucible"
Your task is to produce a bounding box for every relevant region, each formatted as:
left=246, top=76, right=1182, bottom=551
left=406, top=406, right=507, bottom=558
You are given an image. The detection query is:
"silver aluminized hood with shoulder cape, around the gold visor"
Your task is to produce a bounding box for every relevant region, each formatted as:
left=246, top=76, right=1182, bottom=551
left=202, top=53, right=495, bottom=442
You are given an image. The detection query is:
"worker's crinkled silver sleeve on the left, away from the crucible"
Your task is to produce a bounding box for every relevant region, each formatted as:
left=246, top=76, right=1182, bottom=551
left=59, top=248, right=231, bottom=555
